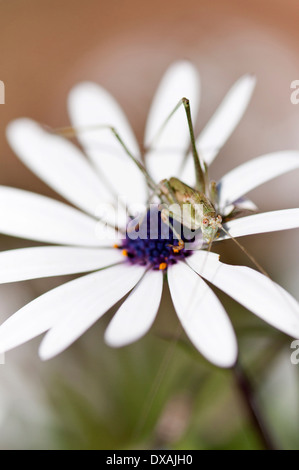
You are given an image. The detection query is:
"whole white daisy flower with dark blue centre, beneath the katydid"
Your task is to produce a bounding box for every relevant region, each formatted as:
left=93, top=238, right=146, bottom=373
left=0, top=62, right=299, bottom=367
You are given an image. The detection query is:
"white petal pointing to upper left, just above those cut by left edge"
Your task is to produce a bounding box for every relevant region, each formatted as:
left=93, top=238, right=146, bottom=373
left=7, top=118, right=116, bottom=221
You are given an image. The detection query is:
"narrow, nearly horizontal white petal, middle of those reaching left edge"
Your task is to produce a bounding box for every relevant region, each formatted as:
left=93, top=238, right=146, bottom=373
left=0, top=246, right=124, bottom=284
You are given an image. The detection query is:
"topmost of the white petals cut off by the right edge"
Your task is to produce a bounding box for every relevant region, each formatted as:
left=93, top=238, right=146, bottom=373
left=218, top=150, right=299, bottom=207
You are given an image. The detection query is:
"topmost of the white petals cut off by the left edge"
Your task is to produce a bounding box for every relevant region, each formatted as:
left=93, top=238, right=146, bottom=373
left=0, top=186, right=117, bottom=246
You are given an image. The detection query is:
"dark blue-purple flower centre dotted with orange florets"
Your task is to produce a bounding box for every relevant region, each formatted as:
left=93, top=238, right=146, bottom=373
left=118, top=209, right=192, bottom=270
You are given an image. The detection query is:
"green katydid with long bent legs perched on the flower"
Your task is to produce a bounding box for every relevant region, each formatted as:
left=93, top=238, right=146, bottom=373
left=56, top=98, right=265, bottom=266
